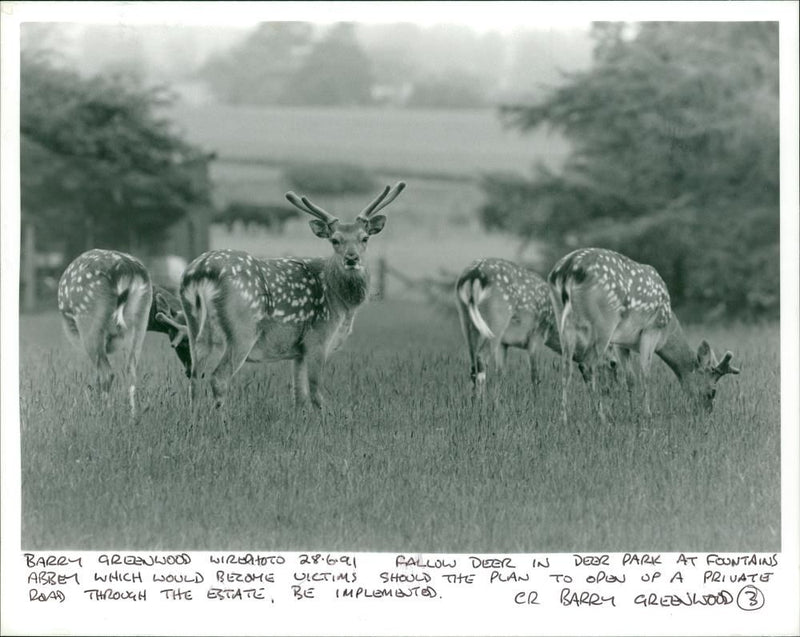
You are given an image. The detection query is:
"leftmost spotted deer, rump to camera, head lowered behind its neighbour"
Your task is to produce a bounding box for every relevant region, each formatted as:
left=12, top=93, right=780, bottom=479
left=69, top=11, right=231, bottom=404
left=58, top=250, right=191, bottom=415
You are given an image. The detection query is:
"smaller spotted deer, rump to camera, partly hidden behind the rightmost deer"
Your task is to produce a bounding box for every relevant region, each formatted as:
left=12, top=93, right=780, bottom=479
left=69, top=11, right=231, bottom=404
left=456, top=258, right=617, bottom=390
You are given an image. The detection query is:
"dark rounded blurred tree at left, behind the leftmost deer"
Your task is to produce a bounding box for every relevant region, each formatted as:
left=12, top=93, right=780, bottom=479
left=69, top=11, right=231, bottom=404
left=20, top=53, right=210, bottom=258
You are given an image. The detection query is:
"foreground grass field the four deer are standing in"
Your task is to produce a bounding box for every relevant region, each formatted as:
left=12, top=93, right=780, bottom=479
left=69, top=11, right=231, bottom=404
left=20, top=302, right=780, bottom=552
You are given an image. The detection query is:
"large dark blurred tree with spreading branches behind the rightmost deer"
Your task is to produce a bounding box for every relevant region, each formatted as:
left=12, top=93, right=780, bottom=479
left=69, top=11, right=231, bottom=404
left=487, top=22, right=779, bottom=314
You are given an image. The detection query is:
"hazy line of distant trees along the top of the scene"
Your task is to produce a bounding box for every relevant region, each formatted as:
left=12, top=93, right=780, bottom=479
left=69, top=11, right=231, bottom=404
left=196, top=22, right=587, bottom=108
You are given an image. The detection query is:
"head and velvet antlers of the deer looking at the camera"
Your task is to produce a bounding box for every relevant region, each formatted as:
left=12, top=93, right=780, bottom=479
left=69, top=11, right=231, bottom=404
left=286, top=181, right=406, bottom=272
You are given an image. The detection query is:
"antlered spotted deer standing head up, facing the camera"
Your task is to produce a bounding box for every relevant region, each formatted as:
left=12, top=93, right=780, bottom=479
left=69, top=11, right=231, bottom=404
left=180, top=182, right=405, bottom=407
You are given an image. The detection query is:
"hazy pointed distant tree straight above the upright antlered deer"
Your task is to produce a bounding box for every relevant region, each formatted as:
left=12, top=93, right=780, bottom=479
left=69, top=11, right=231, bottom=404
left=283, top=22, right=372, bottom=106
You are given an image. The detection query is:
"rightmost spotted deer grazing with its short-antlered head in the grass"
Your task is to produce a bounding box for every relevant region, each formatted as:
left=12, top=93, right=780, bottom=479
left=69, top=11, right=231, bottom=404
left=548, top=248, right=739, bottom=423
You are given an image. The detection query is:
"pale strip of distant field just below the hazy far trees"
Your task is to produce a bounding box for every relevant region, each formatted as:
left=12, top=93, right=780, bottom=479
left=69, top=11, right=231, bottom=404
left=166, top=105, right=568, bottom=179
